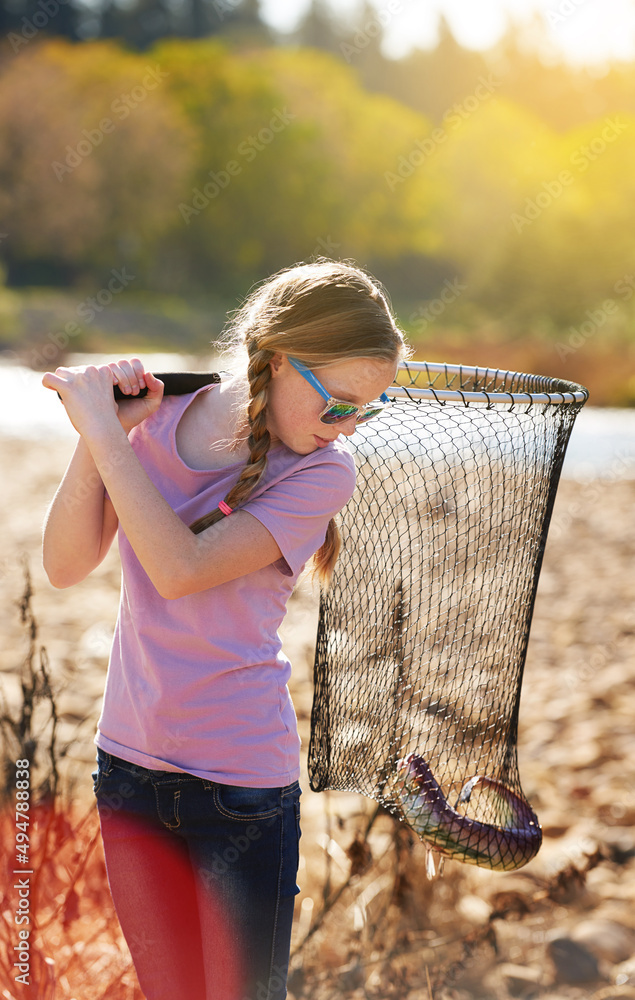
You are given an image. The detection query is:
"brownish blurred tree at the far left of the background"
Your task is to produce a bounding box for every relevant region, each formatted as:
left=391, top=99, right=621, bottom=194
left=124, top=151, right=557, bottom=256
left=0, top=40, right=193, bottom=283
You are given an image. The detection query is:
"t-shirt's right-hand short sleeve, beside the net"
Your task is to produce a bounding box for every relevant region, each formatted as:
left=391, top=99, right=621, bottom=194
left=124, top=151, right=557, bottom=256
left=241, top=448, right=355, bottom=576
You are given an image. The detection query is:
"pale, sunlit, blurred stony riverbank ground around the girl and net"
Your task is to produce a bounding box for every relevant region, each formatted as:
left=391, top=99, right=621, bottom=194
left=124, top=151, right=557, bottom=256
left=0, top=438, right=635, bottom=1000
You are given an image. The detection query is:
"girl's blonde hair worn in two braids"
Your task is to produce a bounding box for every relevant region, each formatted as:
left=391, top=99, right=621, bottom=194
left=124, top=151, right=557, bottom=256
left=190, top=258, right=410, bottom=585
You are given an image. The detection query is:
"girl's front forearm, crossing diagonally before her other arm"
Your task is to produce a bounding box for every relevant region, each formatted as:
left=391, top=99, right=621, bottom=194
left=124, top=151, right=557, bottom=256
left=84, top=422, right=200, bottom=597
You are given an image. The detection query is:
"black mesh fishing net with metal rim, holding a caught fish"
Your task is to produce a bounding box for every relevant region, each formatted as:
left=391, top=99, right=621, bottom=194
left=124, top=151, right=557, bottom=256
left=308, top=363, right=587, bottom=870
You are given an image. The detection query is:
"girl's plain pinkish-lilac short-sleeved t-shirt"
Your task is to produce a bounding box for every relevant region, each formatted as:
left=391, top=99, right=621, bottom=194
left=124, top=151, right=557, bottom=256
left=95, top=387, right=355, bottom=787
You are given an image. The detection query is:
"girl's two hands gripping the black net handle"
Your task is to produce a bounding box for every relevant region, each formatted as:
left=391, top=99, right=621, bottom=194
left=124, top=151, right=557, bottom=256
left=42, top=358, right=163, bottom=440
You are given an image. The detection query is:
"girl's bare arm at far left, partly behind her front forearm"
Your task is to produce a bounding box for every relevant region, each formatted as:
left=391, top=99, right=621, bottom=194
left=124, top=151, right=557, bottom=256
left=42, top=438, right=116, bottom=587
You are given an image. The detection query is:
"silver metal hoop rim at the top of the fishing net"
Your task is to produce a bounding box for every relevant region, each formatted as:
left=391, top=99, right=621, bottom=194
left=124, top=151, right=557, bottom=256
left=388, top=361, right=589, bottom=406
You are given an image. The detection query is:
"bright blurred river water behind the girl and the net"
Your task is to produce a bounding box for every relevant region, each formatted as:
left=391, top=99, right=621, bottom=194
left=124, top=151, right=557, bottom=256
left=0, top=354, right=635, bottom=481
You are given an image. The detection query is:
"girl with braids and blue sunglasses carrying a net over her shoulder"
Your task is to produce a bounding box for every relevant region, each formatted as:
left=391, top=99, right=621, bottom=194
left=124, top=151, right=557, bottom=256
left=43, top=260, right=407, bottom=1000
